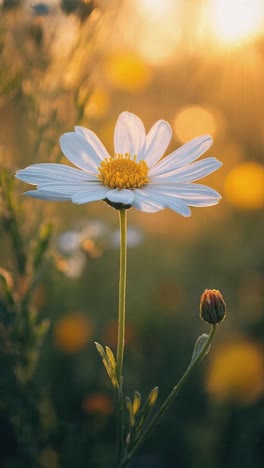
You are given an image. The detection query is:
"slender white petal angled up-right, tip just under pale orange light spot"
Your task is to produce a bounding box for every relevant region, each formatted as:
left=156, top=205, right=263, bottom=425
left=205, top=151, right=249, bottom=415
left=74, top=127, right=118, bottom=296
left=149, top=135, right=213, bottom=176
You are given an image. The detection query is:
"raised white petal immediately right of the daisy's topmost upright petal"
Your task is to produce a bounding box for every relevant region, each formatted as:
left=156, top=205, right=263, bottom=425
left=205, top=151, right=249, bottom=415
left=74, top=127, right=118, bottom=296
left=142, top=120, right=172, bottom=167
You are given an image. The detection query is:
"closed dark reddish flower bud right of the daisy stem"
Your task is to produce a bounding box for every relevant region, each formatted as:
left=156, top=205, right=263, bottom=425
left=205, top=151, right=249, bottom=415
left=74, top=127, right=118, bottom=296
left=200, top=289, right=226, bottom=325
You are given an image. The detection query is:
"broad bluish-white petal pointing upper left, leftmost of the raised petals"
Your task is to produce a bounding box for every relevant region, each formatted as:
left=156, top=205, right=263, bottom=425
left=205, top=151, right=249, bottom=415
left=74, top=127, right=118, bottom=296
left=60, top=132, right=101, bottom=174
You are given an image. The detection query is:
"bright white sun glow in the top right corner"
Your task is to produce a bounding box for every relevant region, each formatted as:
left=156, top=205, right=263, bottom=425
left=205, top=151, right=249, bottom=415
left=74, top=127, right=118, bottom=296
left=209, top=0, right=264, bottom=45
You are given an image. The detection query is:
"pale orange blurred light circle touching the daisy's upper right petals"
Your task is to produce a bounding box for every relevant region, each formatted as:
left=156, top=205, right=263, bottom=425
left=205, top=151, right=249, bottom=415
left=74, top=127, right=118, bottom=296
left=174, top=106, right=216, bottom=143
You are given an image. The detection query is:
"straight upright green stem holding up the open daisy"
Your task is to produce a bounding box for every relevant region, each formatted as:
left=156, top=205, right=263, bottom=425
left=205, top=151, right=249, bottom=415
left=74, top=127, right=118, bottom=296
left=116, top=210, right=127, bottom=463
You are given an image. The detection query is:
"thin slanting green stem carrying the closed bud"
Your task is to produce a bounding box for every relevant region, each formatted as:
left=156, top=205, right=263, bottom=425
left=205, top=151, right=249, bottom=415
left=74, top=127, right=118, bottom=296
left=119, top=325, right=217, bottom=468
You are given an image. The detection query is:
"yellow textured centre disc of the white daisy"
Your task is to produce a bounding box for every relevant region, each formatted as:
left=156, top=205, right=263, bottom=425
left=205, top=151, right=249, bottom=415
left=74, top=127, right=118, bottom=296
left=98, top=153, right=149, bottom=189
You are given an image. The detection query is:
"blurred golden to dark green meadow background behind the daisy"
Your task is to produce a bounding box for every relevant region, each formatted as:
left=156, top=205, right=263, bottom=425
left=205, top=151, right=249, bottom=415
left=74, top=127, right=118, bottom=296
left=0, top=0, right=264, bottom=468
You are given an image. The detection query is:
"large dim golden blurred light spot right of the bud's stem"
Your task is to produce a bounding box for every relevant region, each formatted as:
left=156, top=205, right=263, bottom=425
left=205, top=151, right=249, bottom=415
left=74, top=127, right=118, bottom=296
left=207, top=340, right=264, bottom=403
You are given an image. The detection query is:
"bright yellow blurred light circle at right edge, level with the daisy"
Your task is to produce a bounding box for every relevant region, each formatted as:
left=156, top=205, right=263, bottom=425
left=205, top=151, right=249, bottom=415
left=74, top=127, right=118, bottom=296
left=224, top=162, right=264, bottom=209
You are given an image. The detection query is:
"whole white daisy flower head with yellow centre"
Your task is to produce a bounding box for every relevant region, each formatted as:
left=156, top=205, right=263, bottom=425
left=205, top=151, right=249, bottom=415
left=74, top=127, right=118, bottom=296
left=16, top=112, right=222, bottom=216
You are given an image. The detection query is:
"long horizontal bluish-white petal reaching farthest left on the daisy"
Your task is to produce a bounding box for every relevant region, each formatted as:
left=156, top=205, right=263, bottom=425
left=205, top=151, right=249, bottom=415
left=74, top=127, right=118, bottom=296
left=16, top=163, right=95, bottom=185
